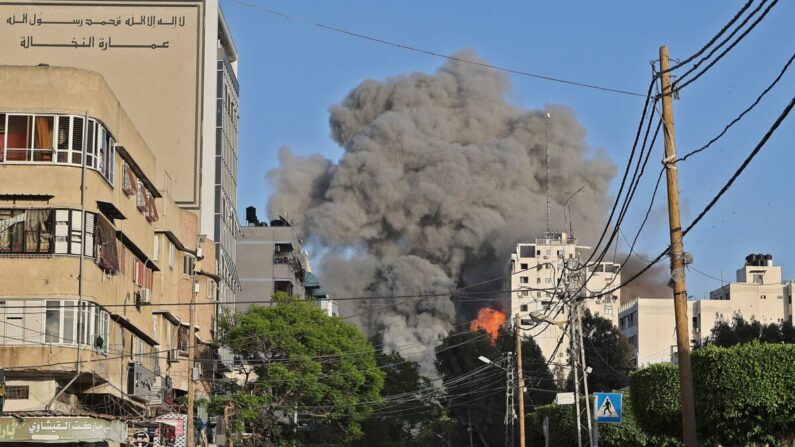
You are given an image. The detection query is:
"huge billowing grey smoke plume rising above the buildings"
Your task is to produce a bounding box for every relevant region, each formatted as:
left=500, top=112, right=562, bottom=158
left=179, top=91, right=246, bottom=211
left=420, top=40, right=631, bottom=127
left=269, top=53, right=616, bottom=372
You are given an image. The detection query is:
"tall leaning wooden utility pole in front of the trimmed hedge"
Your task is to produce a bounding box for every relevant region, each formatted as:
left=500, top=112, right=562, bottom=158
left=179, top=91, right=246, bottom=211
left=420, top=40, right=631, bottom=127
left=660, top=45, right=698, bottom=447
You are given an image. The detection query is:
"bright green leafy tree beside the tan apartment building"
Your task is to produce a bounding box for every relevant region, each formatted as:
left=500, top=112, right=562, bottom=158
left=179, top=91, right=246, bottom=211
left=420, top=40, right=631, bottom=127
left=213, top=294, right=384, bottom=445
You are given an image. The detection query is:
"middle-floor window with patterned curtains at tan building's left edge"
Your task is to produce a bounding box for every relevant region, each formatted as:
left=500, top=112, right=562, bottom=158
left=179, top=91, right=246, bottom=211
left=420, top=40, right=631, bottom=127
left=0, top=209, right=53, bottom=254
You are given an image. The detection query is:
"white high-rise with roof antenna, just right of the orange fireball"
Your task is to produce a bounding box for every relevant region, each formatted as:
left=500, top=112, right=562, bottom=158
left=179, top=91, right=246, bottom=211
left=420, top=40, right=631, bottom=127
left=508, top=232, right=621, bottom=370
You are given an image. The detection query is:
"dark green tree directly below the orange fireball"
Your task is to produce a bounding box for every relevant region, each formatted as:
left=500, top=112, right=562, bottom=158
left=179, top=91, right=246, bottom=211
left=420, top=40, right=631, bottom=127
left=436, top=330, right=556, bottom=446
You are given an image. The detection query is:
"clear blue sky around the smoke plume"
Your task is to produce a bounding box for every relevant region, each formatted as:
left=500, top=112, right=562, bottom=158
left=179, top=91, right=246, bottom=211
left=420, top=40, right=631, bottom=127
left=221, top=0, right=795, bottom=298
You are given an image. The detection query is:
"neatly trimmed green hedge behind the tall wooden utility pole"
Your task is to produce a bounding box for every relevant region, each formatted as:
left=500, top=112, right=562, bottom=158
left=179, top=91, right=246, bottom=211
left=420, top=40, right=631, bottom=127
left=630, top=343, right=795, bottom=446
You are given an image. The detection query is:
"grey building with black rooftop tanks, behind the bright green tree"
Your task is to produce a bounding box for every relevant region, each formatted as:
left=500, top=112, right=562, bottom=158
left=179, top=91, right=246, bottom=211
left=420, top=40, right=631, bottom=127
left=236, top=206, right=339, bottom=316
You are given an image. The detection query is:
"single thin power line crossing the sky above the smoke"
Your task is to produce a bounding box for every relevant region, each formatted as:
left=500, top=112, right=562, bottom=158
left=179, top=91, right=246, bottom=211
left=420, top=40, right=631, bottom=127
left=224, top=0, right=645, bottom=97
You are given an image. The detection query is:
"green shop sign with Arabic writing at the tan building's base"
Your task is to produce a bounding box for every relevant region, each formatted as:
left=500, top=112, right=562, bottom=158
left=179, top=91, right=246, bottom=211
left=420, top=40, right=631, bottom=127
left=0, top=417, right=127, bottom=443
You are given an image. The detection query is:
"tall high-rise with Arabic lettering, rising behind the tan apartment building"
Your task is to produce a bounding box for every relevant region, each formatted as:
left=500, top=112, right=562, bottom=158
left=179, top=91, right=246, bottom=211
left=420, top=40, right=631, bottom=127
left=0, top=0, right=240, bottom=336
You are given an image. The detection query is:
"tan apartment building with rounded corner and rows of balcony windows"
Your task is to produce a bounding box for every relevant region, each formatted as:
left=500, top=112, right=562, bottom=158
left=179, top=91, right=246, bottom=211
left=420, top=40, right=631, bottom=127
left=0, top=65, right=220, bottom=446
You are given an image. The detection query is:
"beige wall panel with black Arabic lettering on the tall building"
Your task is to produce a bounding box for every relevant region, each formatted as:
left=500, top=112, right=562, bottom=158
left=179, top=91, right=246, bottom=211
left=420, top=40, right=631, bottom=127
left=0, top=0, right=205, bottom=205
